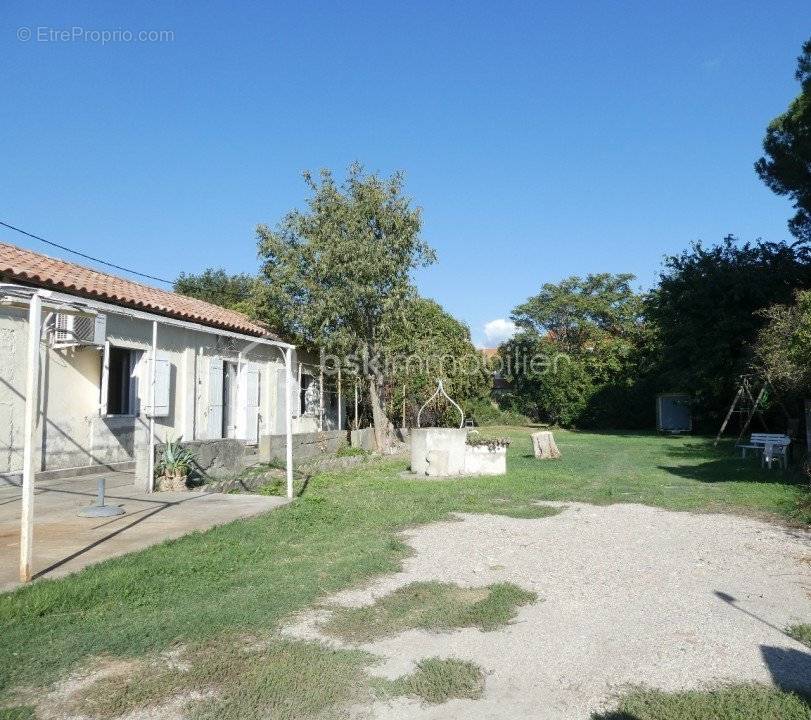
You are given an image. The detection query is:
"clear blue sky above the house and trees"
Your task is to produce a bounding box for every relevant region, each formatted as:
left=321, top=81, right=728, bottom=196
left=0, top=0, right=811, bottom=343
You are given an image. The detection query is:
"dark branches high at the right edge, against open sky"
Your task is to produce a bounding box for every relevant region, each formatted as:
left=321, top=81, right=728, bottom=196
left=755, top=39, right=811, bottom=242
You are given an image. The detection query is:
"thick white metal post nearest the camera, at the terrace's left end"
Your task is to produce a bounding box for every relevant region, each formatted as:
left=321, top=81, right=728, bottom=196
left=20, top=292, right=42, bottom=582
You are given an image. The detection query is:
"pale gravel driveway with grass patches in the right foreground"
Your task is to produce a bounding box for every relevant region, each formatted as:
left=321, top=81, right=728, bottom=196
left=290, top=503, right=811, bottom=720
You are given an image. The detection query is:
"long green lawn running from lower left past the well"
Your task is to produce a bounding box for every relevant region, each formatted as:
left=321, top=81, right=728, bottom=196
left=0, top=428, right=809, bottom=716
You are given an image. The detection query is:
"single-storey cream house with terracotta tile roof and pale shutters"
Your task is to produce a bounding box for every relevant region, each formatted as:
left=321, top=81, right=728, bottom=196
left=0, top=243, right=344, bottom=496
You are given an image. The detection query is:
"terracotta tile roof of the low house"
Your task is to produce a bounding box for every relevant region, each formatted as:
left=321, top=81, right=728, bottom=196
left=0, top=243, right=278, bottom=340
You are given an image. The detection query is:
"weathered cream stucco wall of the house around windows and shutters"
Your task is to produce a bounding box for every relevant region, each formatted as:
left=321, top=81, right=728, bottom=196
left=0, top=307, right=294, bottom=475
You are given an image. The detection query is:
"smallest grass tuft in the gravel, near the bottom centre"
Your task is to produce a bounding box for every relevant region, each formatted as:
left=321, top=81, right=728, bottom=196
left=376, top=658, right=484, bottom=704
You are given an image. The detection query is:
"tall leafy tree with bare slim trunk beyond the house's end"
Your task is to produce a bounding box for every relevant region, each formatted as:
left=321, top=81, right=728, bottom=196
left=257, top=164, right=435, bottom=449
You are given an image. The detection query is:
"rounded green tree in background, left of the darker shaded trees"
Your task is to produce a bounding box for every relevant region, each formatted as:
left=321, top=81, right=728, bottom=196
left=502, top=273, right=652, bottom=427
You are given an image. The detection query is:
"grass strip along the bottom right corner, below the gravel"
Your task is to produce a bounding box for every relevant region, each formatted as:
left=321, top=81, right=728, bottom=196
left=592, top=685, right=811, bottom=720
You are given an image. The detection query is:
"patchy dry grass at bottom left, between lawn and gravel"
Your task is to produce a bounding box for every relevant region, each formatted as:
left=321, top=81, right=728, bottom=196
left=59, top=638, right=370, bottom=720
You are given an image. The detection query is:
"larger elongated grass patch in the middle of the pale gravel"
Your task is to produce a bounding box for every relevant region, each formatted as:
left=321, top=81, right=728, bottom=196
left=323, top=582, right=537, bottom=643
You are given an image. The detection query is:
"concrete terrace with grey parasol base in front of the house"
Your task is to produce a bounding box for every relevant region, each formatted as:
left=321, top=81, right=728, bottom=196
left=0, top=472, right=289, bottom=591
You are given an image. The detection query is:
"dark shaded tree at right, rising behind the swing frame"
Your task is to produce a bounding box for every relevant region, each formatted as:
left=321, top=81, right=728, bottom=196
left=645, top=236, right=811, bottom=423
